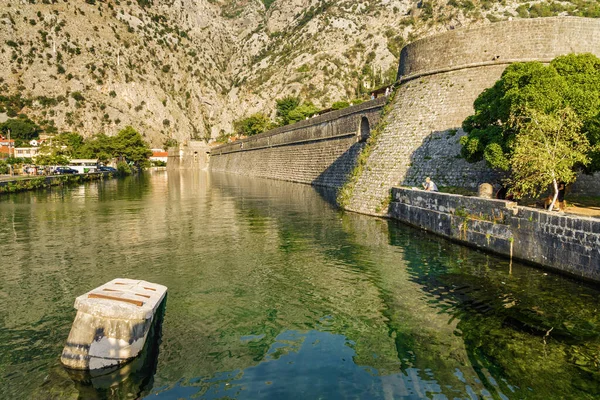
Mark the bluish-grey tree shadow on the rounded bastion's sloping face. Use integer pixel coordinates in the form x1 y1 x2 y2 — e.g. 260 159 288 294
401 128 499 189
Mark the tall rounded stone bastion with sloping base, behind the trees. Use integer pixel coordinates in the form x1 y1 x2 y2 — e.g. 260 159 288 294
348 17 600 215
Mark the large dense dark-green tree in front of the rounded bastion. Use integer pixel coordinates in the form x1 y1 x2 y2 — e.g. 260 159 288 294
460 54 600 194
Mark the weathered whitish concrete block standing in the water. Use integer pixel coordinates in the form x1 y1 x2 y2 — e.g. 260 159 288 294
61 278 167 370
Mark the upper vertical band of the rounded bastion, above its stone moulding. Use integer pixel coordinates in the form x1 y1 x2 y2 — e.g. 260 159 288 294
398 17 600 81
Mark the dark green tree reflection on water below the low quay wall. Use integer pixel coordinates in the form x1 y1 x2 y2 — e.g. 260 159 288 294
390 220 600 398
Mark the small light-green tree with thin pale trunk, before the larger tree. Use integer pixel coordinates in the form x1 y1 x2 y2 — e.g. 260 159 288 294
508 107 590 210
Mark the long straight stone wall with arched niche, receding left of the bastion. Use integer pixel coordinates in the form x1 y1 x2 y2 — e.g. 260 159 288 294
209 97 387 188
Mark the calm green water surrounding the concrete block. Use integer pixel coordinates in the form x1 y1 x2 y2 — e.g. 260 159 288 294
0 172 600 399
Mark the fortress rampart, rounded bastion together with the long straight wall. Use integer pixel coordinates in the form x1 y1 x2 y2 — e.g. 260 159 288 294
210 17 600 209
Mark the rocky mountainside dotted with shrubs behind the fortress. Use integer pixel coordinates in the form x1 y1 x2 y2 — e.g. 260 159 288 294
0 0 600 146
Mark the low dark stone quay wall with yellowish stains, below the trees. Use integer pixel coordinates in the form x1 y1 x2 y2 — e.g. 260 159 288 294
389 188 600 282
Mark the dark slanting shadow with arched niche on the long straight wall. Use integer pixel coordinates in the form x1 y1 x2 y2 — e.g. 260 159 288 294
311 116 371 189
